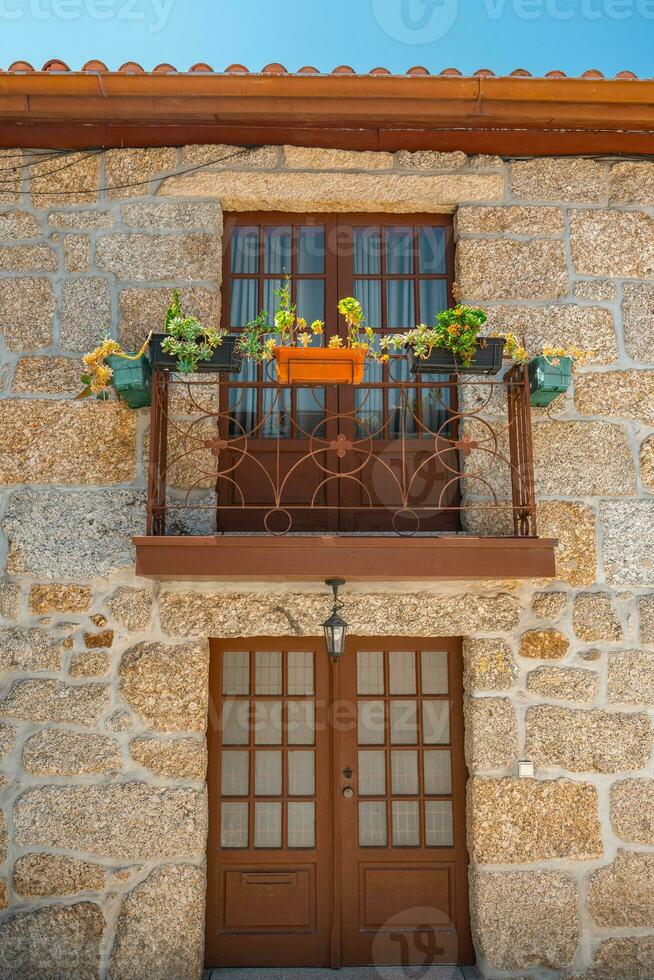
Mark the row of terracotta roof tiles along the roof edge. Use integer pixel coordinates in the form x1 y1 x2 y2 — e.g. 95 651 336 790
0 58 638 80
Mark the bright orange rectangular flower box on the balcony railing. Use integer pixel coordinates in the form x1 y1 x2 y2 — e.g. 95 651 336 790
273 347 366 385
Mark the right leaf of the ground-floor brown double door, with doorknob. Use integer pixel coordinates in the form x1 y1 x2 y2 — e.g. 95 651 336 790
338 638 473 966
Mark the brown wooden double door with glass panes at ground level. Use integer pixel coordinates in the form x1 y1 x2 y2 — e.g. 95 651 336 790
205 637 474 967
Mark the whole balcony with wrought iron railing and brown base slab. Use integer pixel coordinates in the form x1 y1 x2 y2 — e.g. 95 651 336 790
135 367 555 581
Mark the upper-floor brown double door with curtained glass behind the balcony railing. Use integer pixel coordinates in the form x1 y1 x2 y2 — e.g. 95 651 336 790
217 212 459 532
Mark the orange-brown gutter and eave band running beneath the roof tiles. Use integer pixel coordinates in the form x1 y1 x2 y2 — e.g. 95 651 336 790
0 72 654 155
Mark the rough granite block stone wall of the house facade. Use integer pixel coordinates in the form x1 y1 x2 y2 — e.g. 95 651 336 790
0 147 654 980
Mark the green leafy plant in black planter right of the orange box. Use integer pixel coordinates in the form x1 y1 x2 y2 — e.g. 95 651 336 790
382 306 488 367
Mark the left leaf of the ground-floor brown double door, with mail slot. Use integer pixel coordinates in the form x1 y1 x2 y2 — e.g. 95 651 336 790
206 639 332 966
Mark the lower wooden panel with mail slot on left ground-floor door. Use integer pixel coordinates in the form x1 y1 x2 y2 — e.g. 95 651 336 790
223 865 315 932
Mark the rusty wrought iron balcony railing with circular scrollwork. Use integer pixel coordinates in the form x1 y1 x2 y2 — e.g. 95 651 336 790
148 367 536 537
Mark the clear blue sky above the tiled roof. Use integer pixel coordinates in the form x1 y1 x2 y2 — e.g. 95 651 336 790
0 0 654 77
